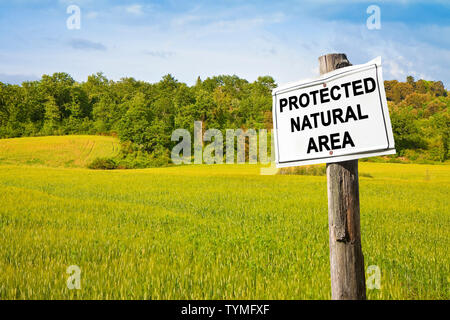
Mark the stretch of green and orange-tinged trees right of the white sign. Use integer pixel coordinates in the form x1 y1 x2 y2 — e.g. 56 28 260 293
384 76 450 162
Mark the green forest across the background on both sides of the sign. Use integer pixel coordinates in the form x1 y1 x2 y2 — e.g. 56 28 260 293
0 73 450 168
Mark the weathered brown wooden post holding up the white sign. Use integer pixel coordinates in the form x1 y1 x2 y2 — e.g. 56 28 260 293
319 53 366 300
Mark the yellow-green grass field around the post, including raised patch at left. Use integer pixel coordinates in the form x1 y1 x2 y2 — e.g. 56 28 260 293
0 136 450 299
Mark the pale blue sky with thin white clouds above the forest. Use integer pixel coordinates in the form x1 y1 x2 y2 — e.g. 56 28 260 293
0 0 450 88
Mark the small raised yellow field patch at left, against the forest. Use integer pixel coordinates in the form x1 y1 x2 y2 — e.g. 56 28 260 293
0 136 120 168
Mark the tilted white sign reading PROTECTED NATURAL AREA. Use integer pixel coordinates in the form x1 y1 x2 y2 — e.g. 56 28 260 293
272 57 395 168
